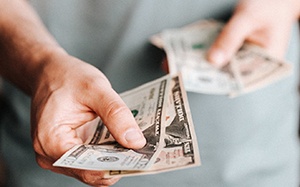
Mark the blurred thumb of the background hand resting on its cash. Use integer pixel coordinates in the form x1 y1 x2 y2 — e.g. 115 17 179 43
207 12 255 67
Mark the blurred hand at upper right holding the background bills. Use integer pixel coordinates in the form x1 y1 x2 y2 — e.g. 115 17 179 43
208 0 300 67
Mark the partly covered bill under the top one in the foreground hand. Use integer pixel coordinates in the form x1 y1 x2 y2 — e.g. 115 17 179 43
108 76 201 176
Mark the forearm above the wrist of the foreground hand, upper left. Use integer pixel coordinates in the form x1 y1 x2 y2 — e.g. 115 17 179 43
0 0 65 94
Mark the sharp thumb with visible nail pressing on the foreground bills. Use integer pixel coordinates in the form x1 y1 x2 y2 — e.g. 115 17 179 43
87 82 146 149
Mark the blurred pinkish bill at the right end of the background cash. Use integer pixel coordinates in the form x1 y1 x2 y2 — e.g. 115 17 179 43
229 44 292 97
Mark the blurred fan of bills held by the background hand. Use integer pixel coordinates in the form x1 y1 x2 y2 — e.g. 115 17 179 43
150 20 292 97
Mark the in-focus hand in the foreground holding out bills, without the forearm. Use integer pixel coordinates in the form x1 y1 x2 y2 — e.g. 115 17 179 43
31 53 146 186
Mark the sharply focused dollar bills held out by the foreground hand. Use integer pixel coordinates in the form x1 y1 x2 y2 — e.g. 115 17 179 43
53 75 200 177
